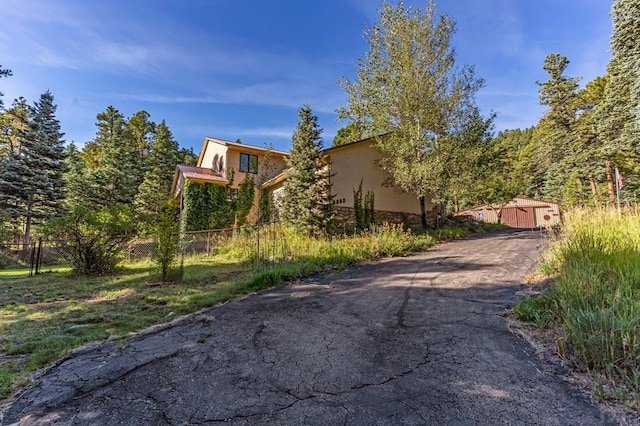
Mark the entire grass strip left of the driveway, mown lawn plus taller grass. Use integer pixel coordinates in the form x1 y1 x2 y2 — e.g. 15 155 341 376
0 221 492 398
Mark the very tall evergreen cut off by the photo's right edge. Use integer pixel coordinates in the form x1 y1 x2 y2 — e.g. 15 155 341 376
597 0 640 198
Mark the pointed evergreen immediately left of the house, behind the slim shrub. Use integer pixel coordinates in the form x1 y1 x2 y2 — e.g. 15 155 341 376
135 120 178 226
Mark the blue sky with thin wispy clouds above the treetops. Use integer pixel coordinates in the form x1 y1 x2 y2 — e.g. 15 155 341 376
0 0 611 152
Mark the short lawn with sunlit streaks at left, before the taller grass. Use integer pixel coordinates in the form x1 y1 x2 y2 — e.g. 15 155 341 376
0 257 252 397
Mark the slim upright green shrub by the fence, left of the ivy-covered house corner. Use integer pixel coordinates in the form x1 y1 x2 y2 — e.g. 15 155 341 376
152 203 180 282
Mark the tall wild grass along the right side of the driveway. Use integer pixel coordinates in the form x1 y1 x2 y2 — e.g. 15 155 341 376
514 210 640 410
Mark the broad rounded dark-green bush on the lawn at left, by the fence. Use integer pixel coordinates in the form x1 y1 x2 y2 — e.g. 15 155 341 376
46 206 134 275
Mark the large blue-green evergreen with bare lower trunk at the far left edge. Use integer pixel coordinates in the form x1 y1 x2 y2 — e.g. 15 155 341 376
0 91 64 245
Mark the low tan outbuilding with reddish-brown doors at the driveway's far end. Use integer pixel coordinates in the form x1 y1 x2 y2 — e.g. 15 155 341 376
456 197 560 228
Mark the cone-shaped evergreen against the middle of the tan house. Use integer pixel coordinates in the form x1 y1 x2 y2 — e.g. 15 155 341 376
282 105 333 235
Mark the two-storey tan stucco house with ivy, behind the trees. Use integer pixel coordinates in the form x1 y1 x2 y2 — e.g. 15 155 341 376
172 137 433 228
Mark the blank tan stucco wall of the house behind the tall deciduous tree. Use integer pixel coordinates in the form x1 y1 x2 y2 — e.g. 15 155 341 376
327 141 433 214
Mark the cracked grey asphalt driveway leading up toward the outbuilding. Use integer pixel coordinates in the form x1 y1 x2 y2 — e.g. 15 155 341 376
2 230 617 425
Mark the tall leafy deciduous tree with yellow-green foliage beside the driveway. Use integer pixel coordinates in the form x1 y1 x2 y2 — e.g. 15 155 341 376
338 0 483 227
